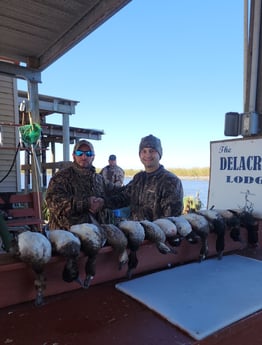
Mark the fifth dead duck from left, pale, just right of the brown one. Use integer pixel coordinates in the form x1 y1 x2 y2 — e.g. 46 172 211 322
118 220 145 278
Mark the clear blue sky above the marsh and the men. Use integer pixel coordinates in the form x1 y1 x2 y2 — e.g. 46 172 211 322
18 0 244 169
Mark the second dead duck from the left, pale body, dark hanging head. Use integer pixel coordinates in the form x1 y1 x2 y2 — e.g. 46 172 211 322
48 229 82 286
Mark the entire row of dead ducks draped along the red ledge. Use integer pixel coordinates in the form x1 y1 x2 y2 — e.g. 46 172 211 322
10 209 258 305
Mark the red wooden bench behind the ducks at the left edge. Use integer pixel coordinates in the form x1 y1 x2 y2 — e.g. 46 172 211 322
0 192 44 234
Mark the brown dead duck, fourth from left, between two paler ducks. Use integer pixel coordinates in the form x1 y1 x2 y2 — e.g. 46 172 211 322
101 224 128 269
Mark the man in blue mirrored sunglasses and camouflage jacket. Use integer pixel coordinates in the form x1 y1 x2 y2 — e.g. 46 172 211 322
45 140 117 230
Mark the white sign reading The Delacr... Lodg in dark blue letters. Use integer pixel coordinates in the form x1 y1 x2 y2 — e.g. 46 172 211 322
207 137 262 218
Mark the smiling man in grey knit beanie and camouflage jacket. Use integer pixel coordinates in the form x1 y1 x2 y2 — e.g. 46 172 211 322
104 135 183 221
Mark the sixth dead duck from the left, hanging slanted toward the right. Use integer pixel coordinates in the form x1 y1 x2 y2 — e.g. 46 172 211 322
140 220 176 254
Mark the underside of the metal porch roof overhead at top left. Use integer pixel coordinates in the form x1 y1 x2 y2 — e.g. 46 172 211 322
0 0 131 71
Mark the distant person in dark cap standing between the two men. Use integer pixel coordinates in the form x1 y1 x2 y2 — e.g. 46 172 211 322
100 155 125 187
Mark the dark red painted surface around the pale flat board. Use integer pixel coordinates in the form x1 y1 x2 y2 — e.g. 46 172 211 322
0 249 262 345
